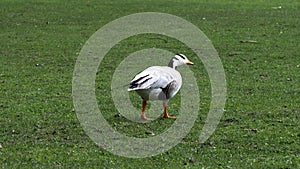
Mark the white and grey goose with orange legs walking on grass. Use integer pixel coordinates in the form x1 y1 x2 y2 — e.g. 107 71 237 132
128 54 193 120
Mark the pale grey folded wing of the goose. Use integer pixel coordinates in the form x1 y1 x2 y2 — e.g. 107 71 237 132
128 66 175 91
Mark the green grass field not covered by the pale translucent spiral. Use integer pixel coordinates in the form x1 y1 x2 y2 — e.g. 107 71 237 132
0 0 300 168
